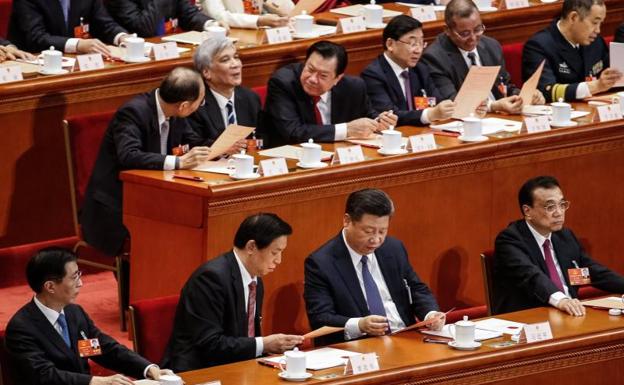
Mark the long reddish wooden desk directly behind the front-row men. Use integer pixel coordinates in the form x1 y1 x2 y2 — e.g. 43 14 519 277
121 107 624 332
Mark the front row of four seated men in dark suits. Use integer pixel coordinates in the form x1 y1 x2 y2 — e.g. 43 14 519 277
6 176 624 385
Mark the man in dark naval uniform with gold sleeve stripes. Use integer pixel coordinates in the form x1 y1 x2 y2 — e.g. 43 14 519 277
522 0 622 102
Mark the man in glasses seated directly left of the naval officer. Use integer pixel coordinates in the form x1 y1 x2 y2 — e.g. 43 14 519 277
422 0 544 114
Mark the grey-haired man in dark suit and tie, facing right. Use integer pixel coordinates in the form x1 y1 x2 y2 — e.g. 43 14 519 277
189 37 261 154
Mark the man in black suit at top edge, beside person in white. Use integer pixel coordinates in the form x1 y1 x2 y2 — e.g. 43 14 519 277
106 0 218 37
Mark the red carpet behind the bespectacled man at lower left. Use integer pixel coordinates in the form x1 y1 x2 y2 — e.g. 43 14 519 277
0 271 132 349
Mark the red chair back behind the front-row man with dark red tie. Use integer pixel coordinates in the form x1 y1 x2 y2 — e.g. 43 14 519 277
130 295 180 363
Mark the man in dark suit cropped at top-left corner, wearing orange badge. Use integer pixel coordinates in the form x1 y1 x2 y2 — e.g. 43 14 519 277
9 0 126 56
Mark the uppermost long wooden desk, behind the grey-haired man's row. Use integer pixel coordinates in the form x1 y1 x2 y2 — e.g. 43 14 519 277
0 0 624 247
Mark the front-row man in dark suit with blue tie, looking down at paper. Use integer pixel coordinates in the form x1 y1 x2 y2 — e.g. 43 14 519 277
303 189 445 343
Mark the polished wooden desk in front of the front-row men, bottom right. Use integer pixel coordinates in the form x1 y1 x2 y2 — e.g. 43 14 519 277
181 308 624 385
